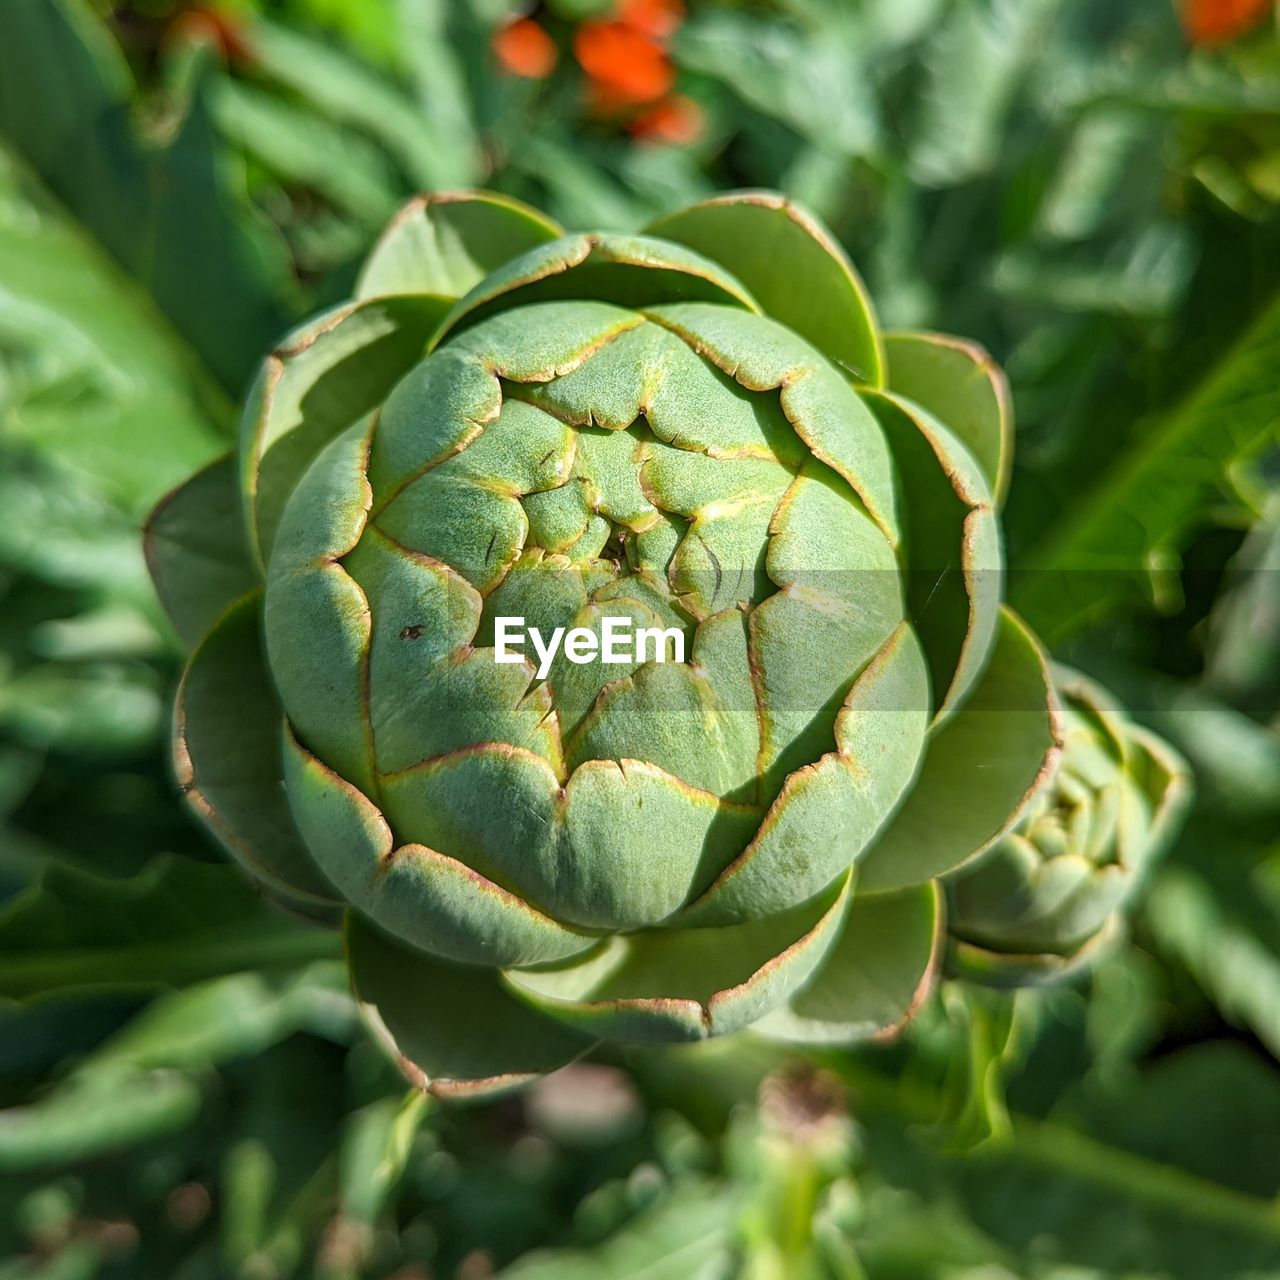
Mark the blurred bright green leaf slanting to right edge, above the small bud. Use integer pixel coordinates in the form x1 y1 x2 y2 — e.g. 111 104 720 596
1012 288 1280 643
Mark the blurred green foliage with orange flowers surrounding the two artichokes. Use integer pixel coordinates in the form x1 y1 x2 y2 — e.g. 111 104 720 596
0 0 1280 1280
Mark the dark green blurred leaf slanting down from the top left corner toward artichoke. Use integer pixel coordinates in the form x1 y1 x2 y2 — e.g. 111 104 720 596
0 0 287 393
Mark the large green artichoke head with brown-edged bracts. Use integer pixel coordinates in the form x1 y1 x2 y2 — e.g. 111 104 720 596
148 193 1060 1093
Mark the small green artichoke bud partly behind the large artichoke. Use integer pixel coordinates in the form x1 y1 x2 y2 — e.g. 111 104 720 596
946 667 1190 987
